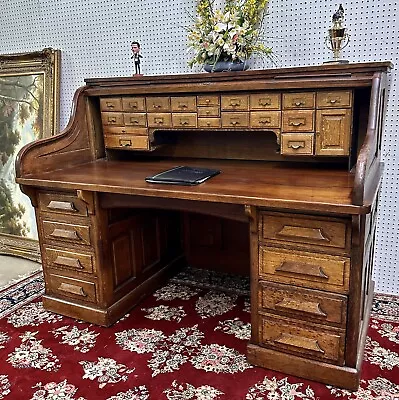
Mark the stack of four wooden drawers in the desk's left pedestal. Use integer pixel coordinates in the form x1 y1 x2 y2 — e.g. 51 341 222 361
38 191 99 303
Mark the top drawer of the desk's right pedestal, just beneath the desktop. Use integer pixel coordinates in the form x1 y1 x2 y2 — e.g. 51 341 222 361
259 213 351 252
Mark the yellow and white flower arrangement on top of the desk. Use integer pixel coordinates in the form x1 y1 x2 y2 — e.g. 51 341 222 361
187 0 272 67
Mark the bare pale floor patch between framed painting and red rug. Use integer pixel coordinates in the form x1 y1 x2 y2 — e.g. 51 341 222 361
0 255 41 289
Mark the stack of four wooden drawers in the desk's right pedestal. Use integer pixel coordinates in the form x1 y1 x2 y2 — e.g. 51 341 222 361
258 212 351 365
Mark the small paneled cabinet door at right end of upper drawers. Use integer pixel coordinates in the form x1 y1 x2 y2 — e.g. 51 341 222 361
315 109 352 156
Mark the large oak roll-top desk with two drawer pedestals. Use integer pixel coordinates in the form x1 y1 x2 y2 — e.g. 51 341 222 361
17 62 392 389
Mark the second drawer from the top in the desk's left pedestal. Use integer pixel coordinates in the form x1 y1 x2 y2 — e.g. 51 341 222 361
43 220 91 246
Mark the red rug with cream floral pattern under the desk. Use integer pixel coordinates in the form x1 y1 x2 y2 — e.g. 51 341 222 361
0 271 399 400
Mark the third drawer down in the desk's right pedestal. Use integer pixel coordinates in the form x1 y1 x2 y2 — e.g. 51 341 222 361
259 281 347 328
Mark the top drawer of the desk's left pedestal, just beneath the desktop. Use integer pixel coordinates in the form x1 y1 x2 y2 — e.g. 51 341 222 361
39 193 88 216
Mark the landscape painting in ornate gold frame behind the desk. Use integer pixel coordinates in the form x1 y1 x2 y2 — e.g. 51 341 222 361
0 48 61 261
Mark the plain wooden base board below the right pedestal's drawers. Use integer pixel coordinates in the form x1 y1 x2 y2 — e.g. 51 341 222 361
247 343 360 390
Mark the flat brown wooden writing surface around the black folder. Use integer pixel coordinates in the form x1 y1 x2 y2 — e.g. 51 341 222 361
19 159 367 214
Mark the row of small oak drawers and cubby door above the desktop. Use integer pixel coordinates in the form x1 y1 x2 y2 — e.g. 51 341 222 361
100 90 352 156
